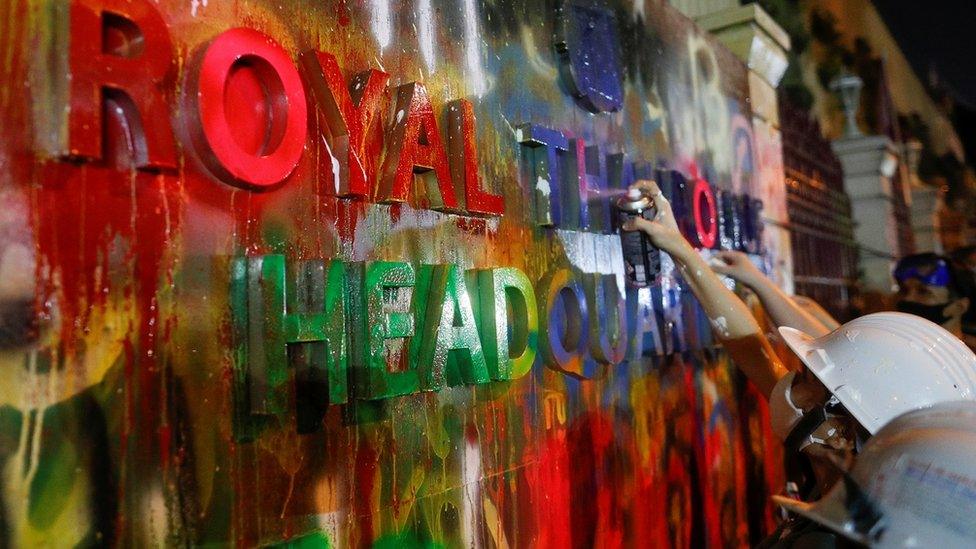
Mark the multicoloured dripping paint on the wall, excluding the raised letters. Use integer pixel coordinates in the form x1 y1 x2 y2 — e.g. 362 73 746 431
0 0 779 547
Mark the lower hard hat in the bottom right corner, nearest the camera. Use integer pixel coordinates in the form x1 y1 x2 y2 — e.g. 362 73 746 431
773 401 976 549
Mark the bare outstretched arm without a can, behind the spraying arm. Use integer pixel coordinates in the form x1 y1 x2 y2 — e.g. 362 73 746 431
710 252 830 337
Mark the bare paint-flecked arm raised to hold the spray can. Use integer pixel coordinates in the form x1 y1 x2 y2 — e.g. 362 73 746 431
624 181 786 396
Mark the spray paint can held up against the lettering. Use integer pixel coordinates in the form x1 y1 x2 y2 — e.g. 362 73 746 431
616 189 661 288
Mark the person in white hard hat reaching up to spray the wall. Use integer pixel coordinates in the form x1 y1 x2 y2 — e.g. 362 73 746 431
624 181 976 510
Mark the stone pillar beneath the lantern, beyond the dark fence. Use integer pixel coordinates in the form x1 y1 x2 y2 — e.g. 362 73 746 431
833 135 899 293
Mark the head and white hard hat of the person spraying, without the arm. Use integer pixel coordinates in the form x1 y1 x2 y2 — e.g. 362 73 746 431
770 312 976 494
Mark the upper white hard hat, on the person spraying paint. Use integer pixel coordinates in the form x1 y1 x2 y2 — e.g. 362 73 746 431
779 313 976 435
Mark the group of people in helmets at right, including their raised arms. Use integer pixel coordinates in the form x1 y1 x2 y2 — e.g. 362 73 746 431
623 181 976 548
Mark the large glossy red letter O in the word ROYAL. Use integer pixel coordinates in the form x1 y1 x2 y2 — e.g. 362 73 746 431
188 29 308 189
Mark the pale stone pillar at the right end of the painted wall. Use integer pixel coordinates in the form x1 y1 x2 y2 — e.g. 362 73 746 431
695 2 793 293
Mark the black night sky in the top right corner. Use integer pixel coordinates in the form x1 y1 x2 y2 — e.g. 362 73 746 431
874 0 976 164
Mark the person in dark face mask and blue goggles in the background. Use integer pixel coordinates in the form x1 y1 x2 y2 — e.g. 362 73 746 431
893 253 969 338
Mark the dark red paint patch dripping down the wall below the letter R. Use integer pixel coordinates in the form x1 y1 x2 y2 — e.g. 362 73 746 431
30 97 181 535
